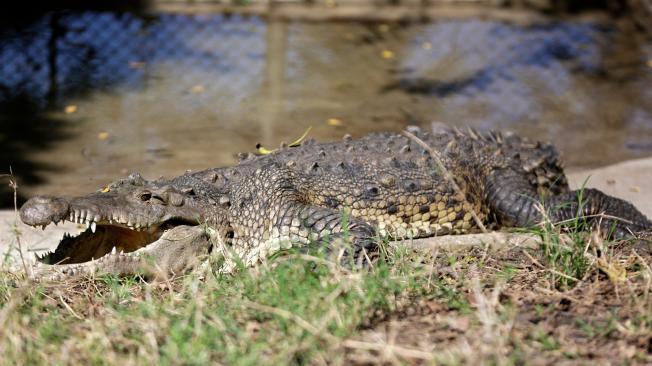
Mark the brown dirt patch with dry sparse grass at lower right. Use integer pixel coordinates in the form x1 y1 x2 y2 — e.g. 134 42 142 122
347 243 652 365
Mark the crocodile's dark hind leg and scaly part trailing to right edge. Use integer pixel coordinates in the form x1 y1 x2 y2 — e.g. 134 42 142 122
486 170 652 238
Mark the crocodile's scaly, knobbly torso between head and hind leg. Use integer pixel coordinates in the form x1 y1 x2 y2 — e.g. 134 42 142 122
176 127 566 266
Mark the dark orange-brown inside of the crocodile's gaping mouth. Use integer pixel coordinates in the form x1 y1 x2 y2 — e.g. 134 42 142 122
38 215 198 264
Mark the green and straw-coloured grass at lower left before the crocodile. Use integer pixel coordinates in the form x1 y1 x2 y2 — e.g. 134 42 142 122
0 240 426 364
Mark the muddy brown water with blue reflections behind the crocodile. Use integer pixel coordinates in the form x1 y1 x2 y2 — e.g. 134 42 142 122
0 12 652 202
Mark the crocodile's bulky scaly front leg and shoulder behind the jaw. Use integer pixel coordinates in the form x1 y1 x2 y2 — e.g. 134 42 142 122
224 163 376 266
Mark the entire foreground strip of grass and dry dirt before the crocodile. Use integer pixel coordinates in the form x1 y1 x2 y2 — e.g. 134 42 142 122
0 229 652 364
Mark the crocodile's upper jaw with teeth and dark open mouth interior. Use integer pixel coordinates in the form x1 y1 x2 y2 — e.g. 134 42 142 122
20 190 209 264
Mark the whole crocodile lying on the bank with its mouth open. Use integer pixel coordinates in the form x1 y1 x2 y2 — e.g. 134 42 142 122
20 126 652 274
